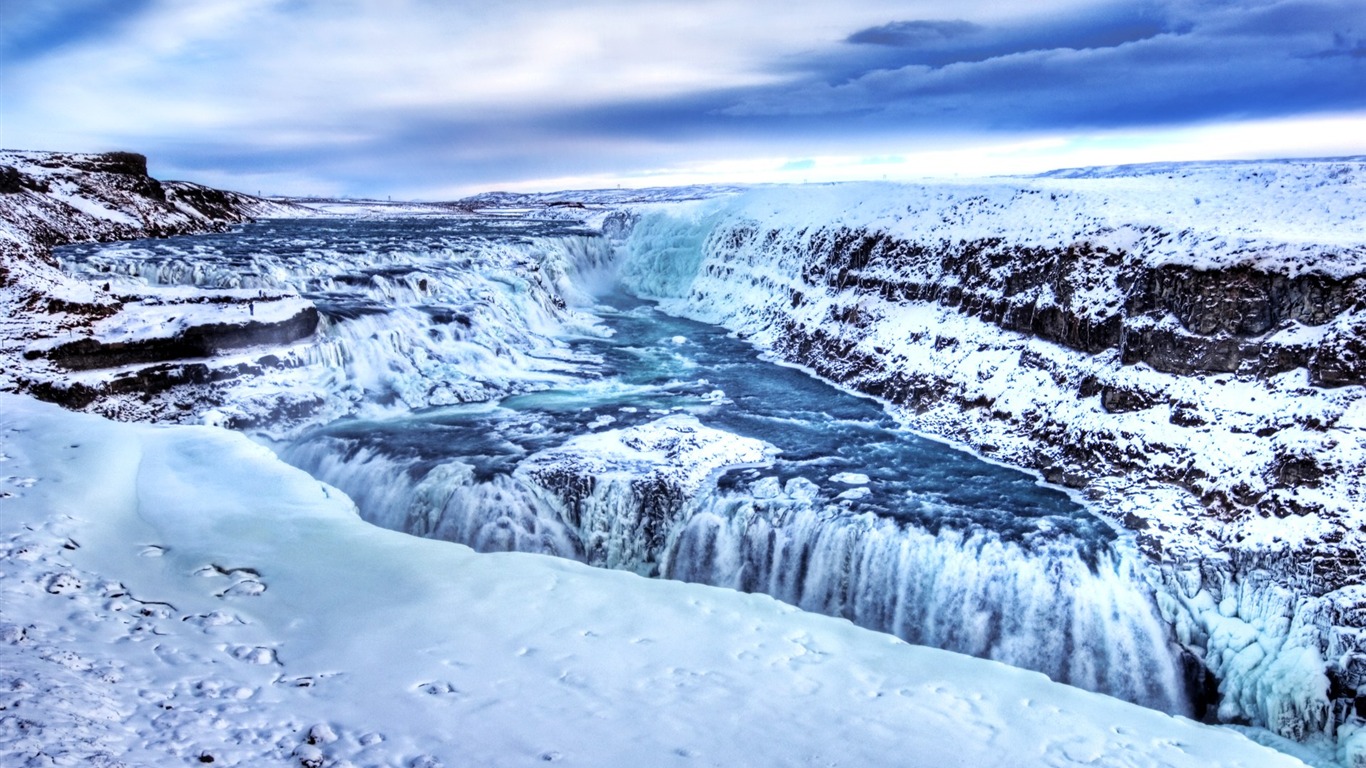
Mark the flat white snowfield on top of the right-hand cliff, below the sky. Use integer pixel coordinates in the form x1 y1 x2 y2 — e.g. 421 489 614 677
620 159 1366 277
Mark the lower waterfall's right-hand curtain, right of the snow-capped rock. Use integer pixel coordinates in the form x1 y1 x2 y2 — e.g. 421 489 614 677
664 478 1188 712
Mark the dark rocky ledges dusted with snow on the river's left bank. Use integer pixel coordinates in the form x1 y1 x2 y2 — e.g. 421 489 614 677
0 150 318 418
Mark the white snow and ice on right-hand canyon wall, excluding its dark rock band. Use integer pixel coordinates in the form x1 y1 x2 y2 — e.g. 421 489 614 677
622 159 1366 748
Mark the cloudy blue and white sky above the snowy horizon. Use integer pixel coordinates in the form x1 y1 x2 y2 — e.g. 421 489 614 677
0 0 1366 200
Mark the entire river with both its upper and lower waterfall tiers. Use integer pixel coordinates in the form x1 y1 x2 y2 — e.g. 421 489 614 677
67 212 1188 713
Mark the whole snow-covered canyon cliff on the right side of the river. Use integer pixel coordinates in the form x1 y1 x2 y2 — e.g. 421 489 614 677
623 160 1366 738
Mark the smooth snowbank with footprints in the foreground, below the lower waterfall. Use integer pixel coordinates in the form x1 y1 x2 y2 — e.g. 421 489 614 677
0 395 1302 768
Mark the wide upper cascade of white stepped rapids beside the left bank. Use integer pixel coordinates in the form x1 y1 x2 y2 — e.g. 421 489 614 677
61 217 615 415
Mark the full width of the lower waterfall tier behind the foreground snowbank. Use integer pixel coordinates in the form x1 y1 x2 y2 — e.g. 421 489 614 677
281 437 1190 715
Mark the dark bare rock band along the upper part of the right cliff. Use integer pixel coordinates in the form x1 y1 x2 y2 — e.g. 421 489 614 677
743 225 1366 387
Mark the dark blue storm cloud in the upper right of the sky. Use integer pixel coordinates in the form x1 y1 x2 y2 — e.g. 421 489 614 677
725 0 1366 130
